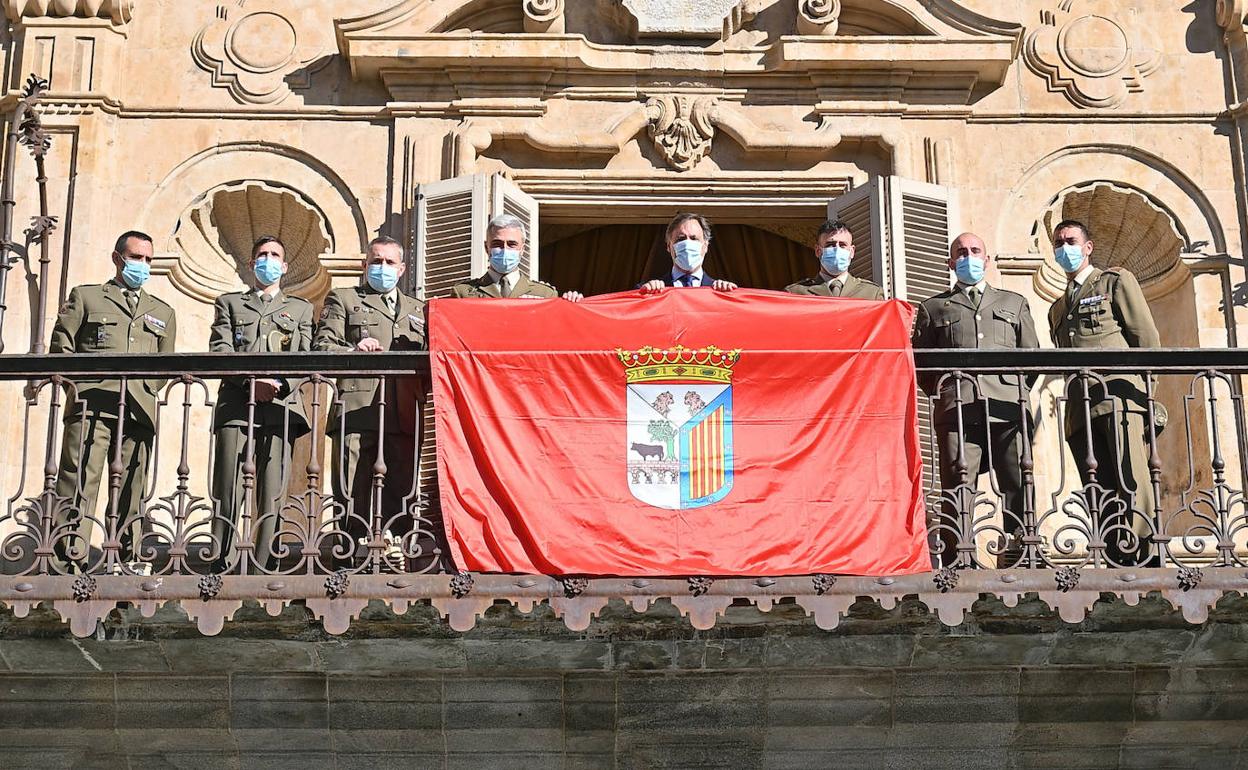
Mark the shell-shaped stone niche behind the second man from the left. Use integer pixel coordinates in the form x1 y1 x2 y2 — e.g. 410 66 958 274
170 182 333 302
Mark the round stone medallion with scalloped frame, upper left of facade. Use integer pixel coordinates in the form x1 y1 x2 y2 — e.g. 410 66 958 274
191 0 329 105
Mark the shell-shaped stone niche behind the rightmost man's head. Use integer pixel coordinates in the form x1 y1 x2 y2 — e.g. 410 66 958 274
1042 182 1183 283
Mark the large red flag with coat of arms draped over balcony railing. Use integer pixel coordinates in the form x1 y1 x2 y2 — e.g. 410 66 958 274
429 288 930 575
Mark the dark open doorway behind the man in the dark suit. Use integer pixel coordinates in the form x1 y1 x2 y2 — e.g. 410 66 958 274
538 221 819 296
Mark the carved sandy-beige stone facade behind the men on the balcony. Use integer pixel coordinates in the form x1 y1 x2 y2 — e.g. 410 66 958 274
0 0 1248 559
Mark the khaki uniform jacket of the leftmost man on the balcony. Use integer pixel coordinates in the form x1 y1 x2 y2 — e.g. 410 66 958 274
49 281 177 426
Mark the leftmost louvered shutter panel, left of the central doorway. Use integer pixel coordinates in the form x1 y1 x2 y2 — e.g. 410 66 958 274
409 175 489 300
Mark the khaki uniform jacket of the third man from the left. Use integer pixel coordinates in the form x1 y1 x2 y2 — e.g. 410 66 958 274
312 286 424 434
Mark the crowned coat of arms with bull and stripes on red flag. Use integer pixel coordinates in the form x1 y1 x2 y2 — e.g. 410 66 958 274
615 344 741 510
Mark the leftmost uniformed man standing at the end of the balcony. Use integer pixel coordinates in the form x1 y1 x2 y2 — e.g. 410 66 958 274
49 231 177 573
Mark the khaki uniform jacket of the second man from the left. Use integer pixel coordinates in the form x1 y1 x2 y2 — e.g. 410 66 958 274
208 291 312 433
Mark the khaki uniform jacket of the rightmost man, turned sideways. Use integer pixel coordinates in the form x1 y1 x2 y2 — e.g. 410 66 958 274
1048 268 1162 433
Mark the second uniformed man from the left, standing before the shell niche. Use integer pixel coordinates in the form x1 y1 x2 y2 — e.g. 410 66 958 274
208 236 312 570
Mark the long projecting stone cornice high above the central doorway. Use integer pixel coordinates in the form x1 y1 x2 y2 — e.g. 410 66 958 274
339 31 1016 105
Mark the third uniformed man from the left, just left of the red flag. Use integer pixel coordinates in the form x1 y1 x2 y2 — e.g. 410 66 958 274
312 236 424 562
